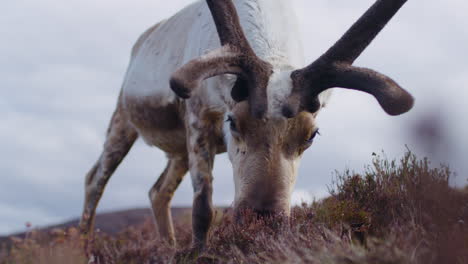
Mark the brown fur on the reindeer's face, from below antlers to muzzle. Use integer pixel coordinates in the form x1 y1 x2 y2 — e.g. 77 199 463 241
232 103 316 214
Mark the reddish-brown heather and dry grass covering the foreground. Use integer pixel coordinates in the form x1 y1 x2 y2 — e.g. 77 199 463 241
0 153 468 264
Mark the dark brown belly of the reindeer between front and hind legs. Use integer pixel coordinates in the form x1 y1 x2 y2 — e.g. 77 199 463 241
123 95 187 155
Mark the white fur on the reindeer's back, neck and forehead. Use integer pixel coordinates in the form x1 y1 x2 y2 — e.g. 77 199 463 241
123 0 310 114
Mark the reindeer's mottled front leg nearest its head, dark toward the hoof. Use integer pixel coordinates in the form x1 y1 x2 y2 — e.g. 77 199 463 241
186 104 222 250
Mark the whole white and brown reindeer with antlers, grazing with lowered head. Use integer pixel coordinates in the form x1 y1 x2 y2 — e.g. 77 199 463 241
80 0 413 248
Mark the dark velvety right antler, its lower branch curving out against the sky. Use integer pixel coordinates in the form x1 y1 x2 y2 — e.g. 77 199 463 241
283 0 414 117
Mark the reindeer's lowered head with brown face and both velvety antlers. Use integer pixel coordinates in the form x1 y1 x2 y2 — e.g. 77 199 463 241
171 0 413 218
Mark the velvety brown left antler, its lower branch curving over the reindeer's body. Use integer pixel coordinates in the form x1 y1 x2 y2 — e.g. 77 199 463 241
170 0 273 118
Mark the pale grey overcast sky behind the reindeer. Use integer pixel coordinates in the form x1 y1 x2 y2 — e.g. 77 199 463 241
0 0 468 234
